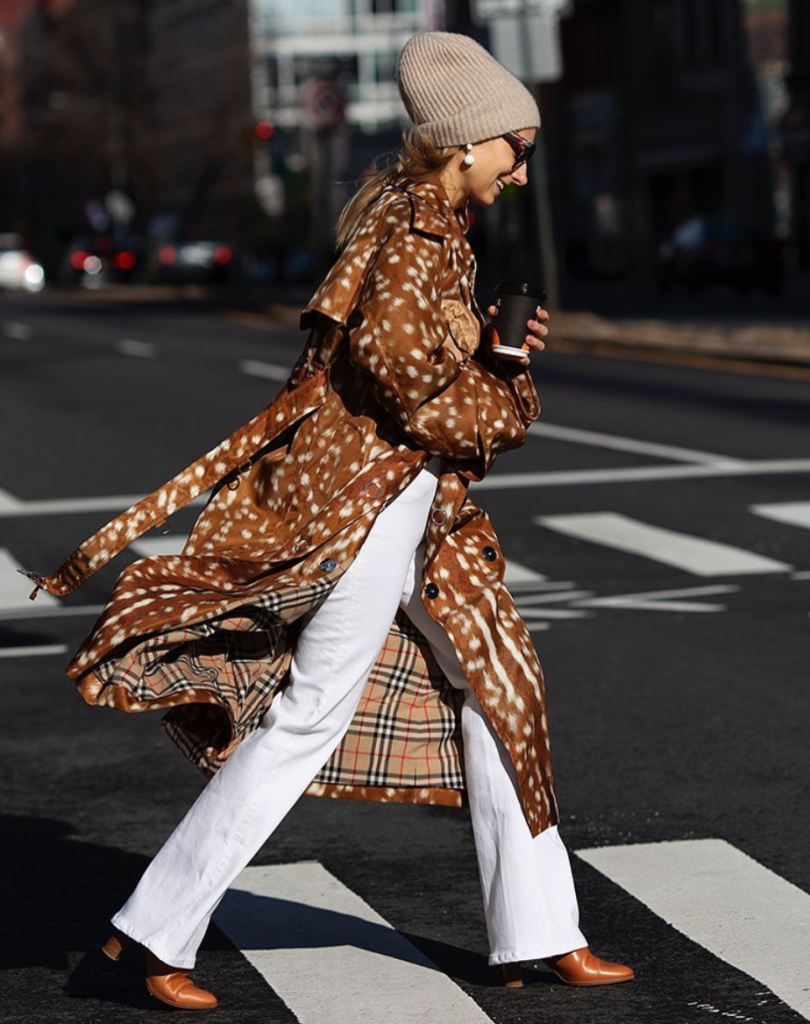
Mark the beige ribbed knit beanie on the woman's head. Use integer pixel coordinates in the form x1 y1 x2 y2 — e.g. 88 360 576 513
396 32 540 145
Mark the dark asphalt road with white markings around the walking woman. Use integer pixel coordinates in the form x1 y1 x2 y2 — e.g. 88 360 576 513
0 296 810 1024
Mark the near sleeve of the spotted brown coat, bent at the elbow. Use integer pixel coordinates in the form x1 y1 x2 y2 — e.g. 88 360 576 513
349 216 535 476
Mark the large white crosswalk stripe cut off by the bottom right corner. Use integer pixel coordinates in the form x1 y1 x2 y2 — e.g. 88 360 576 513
577 839 810 1018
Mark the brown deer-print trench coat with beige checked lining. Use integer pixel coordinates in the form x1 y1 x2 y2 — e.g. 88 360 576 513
32 182 557 835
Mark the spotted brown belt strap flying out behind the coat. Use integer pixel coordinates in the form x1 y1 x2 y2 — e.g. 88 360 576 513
17 367 329 601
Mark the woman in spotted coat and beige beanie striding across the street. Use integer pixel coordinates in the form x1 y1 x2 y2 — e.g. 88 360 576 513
26 33 633 1010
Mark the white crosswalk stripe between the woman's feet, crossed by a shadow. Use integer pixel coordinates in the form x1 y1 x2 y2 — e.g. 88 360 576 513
214 861 492 1024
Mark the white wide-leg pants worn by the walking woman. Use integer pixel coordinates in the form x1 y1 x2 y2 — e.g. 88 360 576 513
113 458 587 968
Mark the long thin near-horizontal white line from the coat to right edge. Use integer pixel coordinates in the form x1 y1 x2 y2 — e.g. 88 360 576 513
471 459 810 490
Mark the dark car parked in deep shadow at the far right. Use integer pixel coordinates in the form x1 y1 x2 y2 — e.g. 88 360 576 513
657 216 784 295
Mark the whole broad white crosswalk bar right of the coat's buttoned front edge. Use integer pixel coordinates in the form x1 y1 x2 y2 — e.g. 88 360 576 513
534 512 793 577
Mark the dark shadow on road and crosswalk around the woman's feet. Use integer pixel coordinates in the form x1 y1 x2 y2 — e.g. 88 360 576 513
0 815 524 1008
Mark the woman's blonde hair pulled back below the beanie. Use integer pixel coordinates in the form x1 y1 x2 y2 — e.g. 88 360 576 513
335 127 466 249
